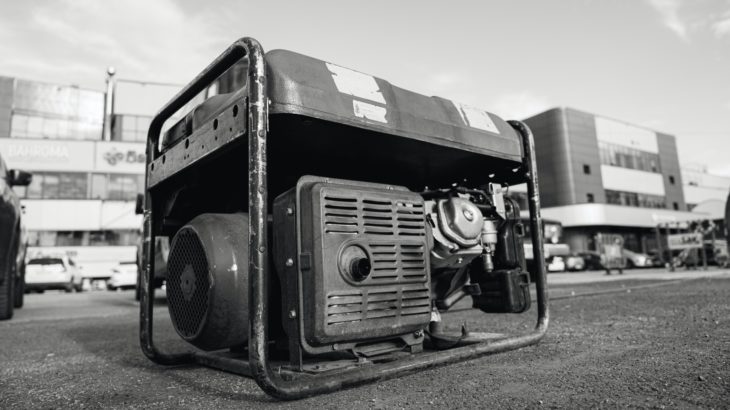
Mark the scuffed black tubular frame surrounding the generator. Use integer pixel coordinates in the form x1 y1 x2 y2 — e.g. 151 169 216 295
140 37 549 400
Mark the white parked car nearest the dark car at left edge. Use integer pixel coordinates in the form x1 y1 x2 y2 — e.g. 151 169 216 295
25 255 83 293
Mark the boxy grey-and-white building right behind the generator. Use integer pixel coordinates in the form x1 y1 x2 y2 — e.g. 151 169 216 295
524 108 698 253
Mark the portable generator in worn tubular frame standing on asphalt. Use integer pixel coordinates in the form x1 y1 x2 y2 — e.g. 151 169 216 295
140 38 548 399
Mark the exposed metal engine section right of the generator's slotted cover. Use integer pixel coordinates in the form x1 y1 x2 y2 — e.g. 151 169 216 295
422 183 529 312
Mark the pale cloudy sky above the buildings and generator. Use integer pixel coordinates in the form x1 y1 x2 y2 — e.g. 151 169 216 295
0 0 730 176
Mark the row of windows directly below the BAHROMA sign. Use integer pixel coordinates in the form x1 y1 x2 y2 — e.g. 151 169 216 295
13 172 144 201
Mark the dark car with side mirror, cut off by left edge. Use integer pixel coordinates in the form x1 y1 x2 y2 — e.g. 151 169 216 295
0 156 33 320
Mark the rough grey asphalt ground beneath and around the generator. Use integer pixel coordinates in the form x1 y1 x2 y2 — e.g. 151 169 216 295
0 268 730 409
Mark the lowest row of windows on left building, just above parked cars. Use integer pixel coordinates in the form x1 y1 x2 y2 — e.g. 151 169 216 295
28 230 141 246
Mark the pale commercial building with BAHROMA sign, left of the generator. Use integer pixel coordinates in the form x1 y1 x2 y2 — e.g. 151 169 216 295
0 77 149 269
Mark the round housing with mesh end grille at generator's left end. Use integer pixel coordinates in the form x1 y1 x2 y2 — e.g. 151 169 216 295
166 213 249 350
